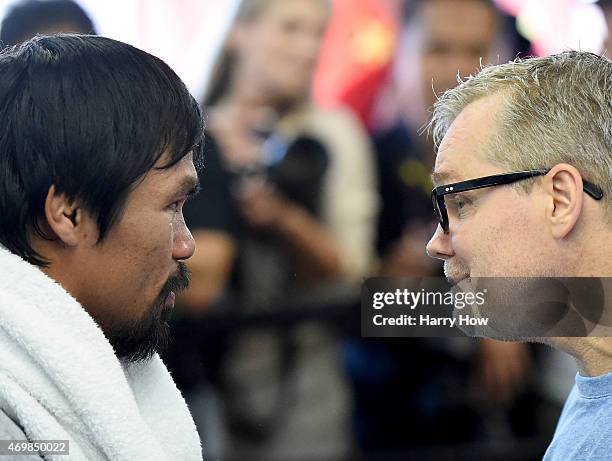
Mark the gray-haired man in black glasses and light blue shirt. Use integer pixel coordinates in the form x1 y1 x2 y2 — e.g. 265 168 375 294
427 51 612 460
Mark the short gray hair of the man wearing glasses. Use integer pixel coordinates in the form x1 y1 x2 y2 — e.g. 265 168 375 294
430 51 612 216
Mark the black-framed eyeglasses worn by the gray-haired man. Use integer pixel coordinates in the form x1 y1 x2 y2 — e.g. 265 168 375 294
431 170 603 233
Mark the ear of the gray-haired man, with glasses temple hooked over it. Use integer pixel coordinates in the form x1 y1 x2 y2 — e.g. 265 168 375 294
547 163 584 239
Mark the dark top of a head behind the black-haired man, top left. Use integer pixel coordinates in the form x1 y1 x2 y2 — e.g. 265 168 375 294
0 0 96 46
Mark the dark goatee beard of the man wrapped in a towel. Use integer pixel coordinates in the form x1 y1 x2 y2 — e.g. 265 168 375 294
106 262 190 362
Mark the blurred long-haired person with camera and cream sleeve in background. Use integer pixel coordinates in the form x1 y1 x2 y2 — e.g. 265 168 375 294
164 0 377 461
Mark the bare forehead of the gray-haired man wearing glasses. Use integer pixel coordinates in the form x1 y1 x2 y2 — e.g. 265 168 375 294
433 95 502 186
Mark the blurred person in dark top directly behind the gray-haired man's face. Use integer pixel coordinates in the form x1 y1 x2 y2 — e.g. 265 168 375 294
346 0 544 453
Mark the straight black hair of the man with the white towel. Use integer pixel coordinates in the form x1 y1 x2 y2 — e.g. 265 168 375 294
0 34 203 267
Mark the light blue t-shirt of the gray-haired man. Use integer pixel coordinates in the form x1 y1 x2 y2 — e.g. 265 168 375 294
543 373 612 461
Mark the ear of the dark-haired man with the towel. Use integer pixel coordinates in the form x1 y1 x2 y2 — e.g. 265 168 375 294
45 185 83 246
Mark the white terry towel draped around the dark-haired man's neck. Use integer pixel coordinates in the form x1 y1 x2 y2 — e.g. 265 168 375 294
0 246 202 461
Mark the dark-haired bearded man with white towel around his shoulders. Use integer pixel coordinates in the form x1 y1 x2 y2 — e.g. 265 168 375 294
0 35 202 461
